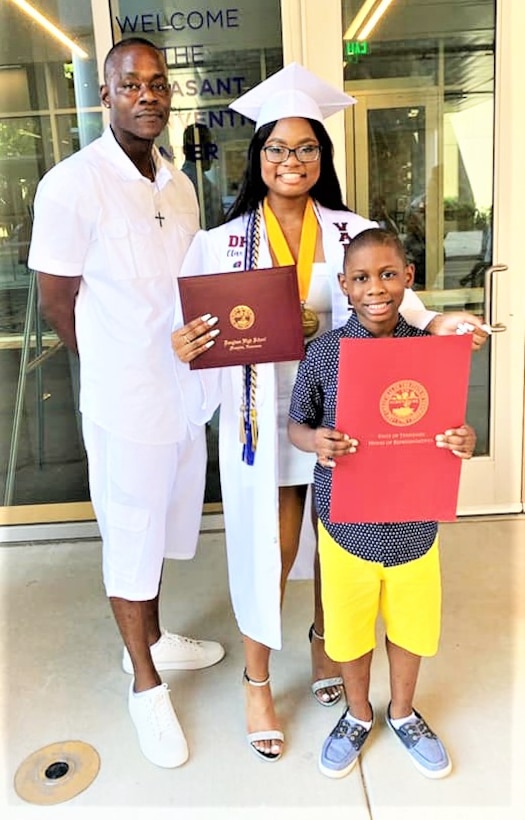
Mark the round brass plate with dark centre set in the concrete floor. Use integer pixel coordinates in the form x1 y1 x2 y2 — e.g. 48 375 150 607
14 740 100 806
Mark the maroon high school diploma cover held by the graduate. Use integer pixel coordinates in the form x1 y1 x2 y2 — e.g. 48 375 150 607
178 265 304 370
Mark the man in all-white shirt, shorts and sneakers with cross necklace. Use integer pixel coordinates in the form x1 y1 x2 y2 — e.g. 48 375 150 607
29 38 224 767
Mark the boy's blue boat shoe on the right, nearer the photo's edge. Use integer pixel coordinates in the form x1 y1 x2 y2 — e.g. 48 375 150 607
385 704 452 780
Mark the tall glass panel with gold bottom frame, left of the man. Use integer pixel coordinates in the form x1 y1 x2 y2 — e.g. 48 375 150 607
0 0 98 527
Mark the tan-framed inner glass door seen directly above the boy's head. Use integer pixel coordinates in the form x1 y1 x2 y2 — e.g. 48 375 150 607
350 89 443 290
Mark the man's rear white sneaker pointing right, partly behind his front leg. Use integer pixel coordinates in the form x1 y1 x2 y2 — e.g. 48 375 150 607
122 630 224 675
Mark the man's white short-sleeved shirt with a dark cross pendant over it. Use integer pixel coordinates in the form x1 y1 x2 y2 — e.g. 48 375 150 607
28 128 200 444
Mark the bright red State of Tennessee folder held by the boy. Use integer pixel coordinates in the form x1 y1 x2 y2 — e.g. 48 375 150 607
330 335 472 523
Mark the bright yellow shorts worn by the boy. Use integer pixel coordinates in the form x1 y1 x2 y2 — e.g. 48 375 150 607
319 521 441 662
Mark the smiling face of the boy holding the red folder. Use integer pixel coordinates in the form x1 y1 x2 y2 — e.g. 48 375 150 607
339 243 414 336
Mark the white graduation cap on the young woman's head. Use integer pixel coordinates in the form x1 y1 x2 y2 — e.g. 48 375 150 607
229 63 356 130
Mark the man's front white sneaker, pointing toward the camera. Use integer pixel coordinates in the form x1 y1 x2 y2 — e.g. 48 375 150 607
128 682 189 769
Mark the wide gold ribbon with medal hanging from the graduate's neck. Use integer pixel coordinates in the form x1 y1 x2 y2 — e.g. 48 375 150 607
263 198 319 338
